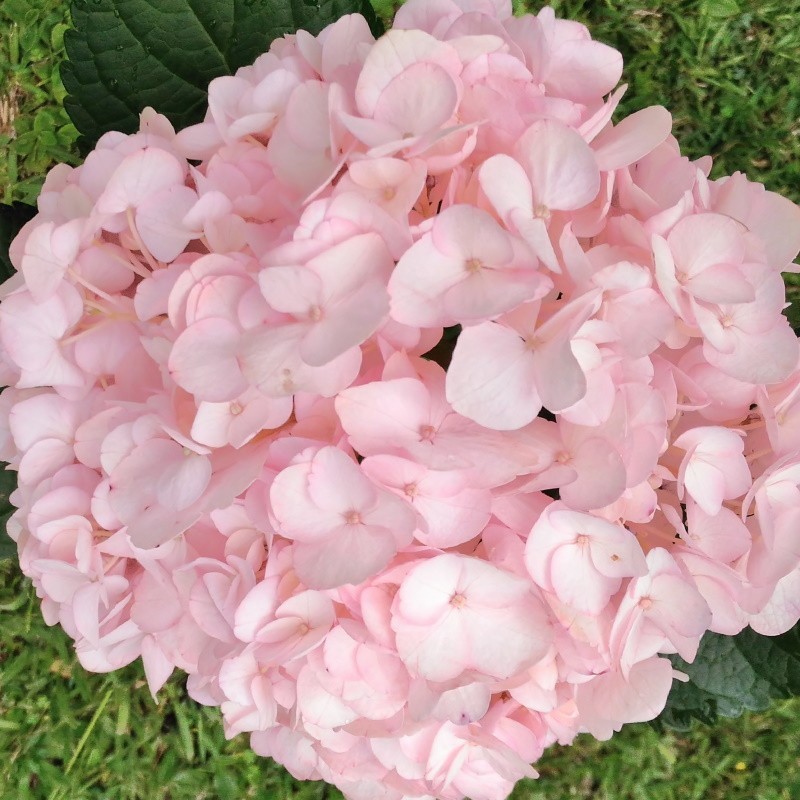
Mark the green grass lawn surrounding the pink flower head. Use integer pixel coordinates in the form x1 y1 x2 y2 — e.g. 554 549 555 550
0 0 800 800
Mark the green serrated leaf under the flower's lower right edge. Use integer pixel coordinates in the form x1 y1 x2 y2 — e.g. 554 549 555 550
656 625 800 730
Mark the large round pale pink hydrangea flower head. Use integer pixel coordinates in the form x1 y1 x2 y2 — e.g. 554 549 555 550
0 0 800 800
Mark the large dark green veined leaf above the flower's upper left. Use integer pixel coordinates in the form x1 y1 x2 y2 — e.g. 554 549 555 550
61 0 380 150
